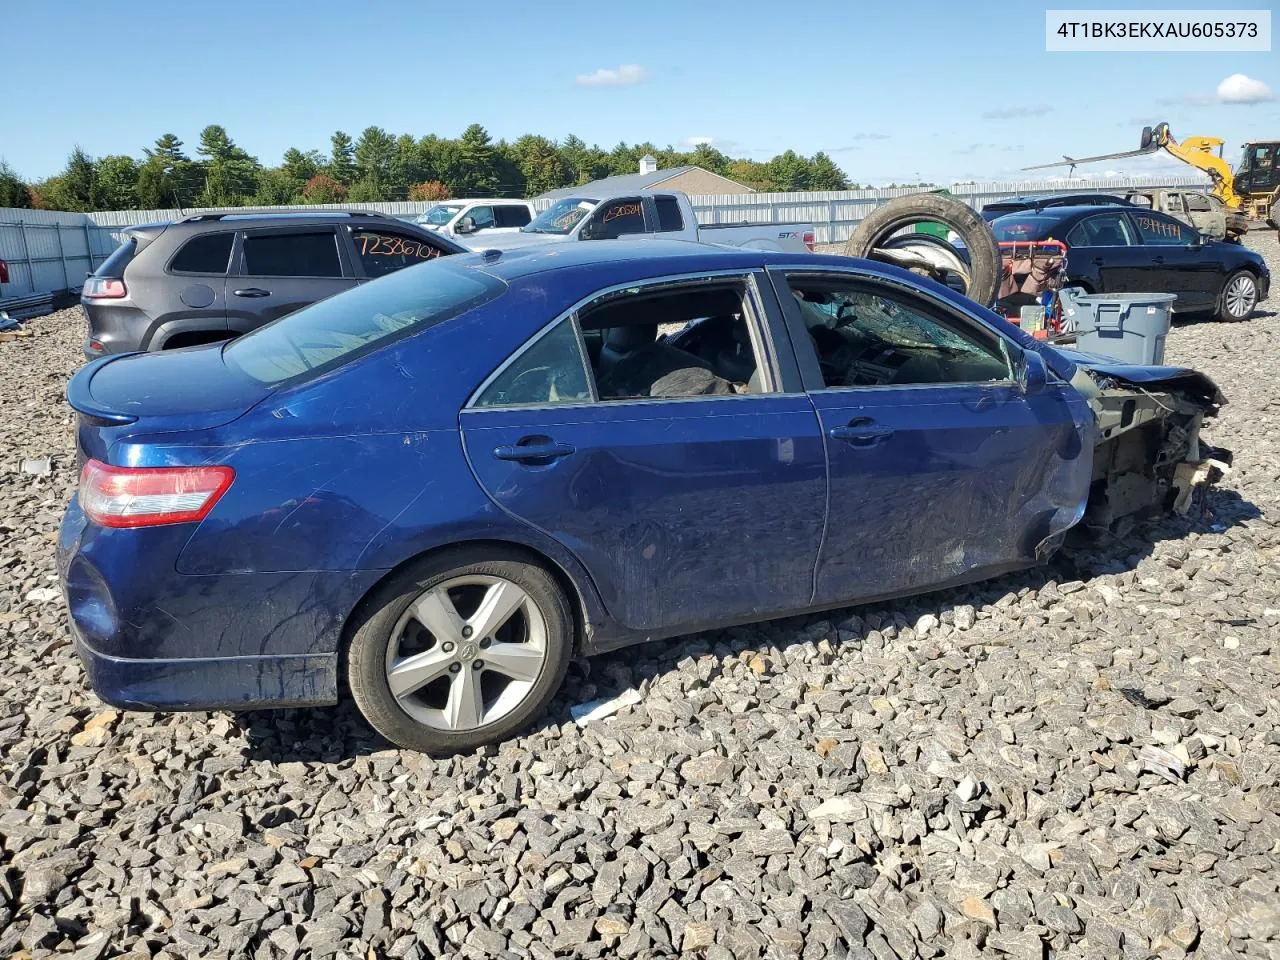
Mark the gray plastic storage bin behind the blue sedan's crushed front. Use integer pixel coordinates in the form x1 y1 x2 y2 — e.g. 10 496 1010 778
1057 287 1176 365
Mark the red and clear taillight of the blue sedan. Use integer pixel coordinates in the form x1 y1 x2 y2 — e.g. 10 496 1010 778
79 460 236 527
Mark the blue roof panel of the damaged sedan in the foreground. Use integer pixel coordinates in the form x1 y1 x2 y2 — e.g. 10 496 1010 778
471 239 849 280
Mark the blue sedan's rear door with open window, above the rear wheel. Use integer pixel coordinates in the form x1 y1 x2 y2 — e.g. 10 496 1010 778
461 275 827 636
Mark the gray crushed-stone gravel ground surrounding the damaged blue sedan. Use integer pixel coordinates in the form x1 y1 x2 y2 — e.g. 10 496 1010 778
0 236 1280 960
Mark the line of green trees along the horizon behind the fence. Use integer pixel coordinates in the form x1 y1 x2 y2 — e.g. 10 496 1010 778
0 123 856 211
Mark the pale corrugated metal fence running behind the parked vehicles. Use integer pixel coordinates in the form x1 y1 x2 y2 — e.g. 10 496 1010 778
0 177 1207 305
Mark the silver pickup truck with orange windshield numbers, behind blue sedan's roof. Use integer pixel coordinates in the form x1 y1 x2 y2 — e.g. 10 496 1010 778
460 189 813 252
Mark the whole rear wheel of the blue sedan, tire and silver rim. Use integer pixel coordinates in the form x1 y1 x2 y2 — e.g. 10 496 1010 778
347 548 573 754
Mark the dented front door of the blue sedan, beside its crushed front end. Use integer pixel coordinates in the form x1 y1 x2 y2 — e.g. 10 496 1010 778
776 270 1093 604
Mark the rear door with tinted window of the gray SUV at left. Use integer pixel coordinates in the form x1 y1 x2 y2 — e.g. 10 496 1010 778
227 225 357 333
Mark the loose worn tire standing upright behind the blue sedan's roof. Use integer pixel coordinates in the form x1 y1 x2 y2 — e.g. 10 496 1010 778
845 193 1001 307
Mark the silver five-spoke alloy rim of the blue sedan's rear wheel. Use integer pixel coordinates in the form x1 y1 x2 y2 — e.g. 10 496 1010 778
387 575 548 732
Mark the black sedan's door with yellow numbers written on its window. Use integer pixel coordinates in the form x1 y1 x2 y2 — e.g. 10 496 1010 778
1129 210 1225 310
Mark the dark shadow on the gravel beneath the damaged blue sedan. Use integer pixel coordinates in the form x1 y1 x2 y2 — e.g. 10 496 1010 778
234 488 1262 763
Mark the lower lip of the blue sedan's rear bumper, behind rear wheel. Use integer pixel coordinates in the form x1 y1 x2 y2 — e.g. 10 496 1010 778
72 625 338 710
